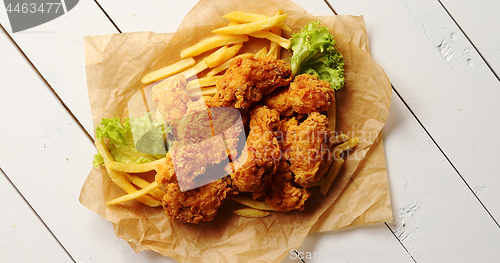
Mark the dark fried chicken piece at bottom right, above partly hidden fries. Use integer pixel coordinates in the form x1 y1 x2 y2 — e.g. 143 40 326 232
265 160 311 212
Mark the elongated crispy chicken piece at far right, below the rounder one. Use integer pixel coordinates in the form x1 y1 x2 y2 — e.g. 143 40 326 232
282 112 330 188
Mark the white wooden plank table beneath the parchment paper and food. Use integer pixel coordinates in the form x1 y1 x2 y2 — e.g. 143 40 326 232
0 0 500 263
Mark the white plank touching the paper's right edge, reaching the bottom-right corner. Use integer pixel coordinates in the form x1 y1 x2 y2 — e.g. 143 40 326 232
382 93 500 263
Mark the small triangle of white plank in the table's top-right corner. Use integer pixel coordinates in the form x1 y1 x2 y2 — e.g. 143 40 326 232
441 0 500 75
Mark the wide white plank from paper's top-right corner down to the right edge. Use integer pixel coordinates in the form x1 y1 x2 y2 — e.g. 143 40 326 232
329 0 500 225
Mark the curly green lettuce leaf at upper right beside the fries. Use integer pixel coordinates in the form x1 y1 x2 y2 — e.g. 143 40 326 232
290 21 345 90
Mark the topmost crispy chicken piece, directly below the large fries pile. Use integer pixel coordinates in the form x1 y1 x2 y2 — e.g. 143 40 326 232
209 56 292 109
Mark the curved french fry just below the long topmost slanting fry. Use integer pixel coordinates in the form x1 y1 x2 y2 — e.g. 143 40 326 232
181 34 249 58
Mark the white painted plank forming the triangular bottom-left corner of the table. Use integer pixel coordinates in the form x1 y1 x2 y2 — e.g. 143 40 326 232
0 171 72 263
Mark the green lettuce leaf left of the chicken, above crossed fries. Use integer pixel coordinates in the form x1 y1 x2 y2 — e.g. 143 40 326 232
92 112 170 167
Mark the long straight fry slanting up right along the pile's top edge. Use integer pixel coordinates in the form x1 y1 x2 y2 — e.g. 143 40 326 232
212 14 287 35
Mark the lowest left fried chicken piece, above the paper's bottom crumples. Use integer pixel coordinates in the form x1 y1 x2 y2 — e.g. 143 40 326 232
162 176 238 224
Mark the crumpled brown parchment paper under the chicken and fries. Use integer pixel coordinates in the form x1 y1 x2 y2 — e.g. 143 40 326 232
80 0 392 262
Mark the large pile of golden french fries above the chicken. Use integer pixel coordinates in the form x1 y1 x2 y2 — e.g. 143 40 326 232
141 11 291 98
